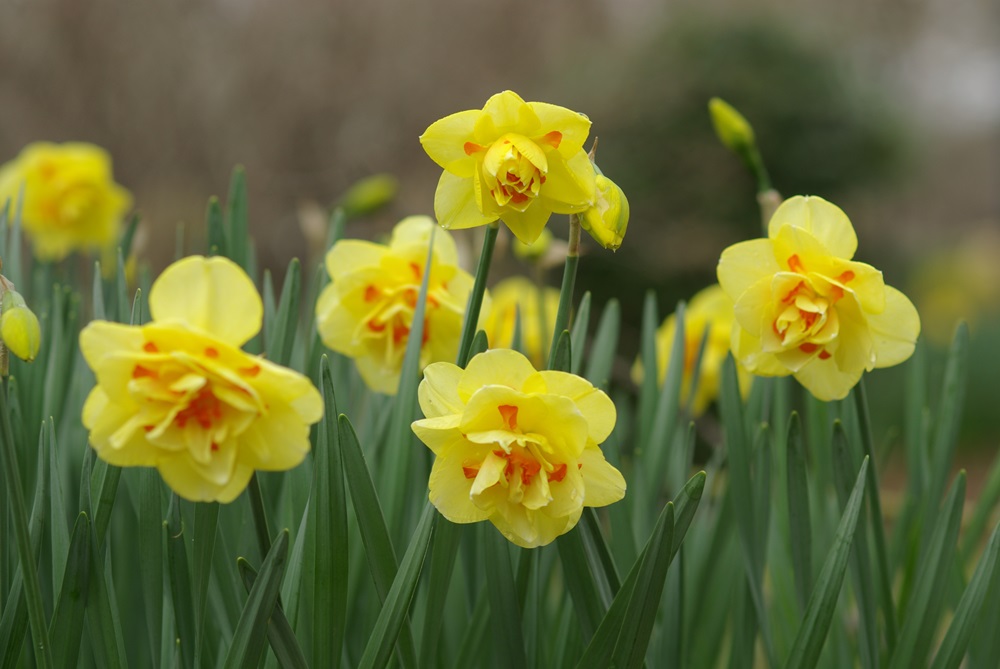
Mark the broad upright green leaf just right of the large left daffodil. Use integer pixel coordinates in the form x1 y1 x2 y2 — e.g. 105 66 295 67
306 356 348 667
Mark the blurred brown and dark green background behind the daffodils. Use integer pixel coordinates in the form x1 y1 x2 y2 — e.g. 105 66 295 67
0 0 1000 448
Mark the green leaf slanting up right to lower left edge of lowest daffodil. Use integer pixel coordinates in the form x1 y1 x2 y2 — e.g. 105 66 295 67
358 502 438 669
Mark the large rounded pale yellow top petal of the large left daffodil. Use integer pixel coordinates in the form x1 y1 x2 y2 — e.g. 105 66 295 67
149 256 264 346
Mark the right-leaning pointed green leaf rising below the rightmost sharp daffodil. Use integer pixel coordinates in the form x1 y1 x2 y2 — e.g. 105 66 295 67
785 457 868 669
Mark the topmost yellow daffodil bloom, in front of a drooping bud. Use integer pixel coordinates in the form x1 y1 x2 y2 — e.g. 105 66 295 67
420 91 596 244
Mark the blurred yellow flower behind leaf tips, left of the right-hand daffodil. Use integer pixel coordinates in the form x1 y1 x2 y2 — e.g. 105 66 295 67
632 284 751 416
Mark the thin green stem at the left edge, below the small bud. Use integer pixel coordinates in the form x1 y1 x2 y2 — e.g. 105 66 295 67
0 378 52 668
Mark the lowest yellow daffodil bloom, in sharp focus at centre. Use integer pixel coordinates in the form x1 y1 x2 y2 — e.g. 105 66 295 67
413 349 625 548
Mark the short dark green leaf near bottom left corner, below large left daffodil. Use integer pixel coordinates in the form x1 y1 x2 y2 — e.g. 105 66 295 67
49 511 90 667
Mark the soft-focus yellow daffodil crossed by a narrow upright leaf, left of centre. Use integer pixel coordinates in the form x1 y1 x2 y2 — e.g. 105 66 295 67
316 216 480 395
